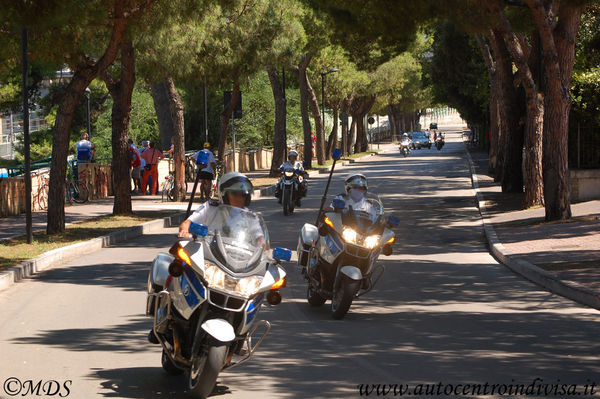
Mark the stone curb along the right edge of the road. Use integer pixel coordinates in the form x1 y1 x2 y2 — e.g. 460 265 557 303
463 142 600 309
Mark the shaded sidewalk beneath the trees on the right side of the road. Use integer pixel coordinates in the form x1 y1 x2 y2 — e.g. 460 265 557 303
467 144 600 309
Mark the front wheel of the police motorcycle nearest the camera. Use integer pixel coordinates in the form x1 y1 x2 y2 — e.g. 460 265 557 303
188 345 227 399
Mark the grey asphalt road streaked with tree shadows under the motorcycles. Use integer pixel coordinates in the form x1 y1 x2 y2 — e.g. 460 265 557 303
0 133 600 399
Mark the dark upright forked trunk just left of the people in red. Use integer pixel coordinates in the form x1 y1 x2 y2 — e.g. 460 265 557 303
101 40 135 215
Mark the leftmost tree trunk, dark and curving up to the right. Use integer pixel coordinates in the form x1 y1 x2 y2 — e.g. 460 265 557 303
46 1 127 234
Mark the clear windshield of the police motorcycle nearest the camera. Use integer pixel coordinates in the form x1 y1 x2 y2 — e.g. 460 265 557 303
205 205 269 274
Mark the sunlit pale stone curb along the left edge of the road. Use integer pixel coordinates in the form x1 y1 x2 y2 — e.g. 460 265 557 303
0 212 185 291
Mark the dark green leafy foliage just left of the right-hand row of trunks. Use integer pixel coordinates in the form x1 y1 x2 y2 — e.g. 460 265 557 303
423 23 489 125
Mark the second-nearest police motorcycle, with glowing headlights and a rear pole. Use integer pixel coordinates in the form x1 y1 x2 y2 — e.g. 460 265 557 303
297 153 398 319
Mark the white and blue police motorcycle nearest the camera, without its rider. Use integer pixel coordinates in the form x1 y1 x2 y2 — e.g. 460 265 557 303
146 205 291 398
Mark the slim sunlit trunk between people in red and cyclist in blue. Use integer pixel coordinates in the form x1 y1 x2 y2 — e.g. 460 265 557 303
164 77 187 201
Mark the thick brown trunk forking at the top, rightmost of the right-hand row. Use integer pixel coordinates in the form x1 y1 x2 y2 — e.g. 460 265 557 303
525 0 585 221
